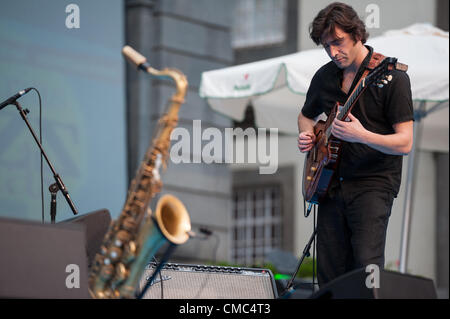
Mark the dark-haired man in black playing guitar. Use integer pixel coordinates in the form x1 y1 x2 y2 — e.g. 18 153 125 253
298 3 413 285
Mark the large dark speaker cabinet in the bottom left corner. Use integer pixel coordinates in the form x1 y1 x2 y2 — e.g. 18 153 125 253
0 218 89 299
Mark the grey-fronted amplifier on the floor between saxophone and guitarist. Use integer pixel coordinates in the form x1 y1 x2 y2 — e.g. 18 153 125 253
139 263 278 299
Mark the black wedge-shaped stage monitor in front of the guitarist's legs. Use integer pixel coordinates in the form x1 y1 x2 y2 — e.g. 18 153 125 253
311 268 437 299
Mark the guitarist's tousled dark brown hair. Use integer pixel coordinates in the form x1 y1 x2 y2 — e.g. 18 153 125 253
309 2 369 45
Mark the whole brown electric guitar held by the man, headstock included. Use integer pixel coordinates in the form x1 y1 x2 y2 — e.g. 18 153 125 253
302 53 408 208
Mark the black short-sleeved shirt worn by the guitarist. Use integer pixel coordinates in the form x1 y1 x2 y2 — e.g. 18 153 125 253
302 46 414 196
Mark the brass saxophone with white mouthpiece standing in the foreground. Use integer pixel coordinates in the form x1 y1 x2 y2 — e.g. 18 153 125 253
89 46 191 298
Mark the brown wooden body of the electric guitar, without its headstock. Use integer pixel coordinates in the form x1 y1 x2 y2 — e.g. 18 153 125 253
303 103 341 204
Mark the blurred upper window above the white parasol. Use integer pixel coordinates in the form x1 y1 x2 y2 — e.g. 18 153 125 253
232 0 287 49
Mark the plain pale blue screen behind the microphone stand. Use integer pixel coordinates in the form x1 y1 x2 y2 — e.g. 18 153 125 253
0 0 128 222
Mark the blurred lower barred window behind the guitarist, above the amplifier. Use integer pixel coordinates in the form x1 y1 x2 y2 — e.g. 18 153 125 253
231 186 282 266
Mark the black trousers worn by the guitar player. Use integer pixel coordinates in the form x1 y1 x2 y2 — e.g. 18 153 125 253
317 182 394 286
